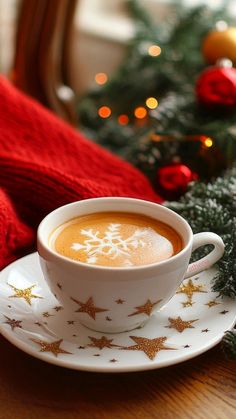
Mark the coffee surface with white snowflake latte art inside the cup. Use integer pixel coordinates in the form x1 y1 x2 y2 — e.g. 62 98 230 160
50 212 183 267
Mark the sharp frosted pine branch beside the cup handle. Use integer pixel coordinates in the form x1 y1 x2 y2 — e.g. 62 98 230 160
167 169 236 298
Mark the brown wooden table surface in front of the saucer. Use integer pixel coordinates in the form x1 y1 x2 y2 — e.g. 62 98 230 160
0 337 236 419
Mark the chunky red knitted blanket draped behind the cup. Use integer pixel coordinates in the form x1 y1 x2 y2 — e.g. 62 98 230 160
0 77 161 268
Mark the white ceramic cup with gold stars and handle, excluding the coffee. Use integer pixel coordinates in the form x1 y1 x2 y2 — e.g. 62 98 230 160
37 198 224 333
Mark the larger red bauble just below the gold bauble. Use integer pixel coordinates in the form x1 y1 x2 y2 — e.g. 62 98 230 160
196 67 236 107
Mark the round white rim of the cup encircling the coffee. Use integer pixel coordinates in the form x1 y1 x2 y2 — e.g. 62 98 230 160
37 197 193 272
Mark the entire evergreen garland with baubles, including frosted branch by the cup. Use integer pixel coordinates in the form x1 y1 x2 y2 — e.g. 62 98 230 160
78 1 236 358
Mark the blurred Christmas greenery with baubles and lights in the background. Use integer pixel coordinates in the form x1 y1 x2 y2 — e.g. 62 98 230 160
78 0 236 199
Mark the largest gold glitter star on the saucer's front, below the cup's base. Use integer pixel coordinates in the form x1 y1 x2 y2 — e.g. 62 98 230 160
120 336 176 360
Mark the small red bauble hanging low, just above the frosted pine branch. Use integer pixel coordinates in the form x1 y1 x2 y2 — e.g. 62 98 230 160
157 163 198 199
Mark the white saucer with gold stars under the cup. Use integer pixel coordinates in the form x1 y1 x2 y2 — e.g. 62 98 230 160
0 253 236 372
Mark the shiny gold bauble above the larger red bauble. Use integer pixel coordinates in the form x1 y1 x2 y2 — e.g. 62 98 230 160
202 27 236 64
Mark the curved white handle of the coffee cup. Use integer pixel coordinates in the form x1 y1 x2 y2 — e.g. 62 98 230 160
184 232 225 279
